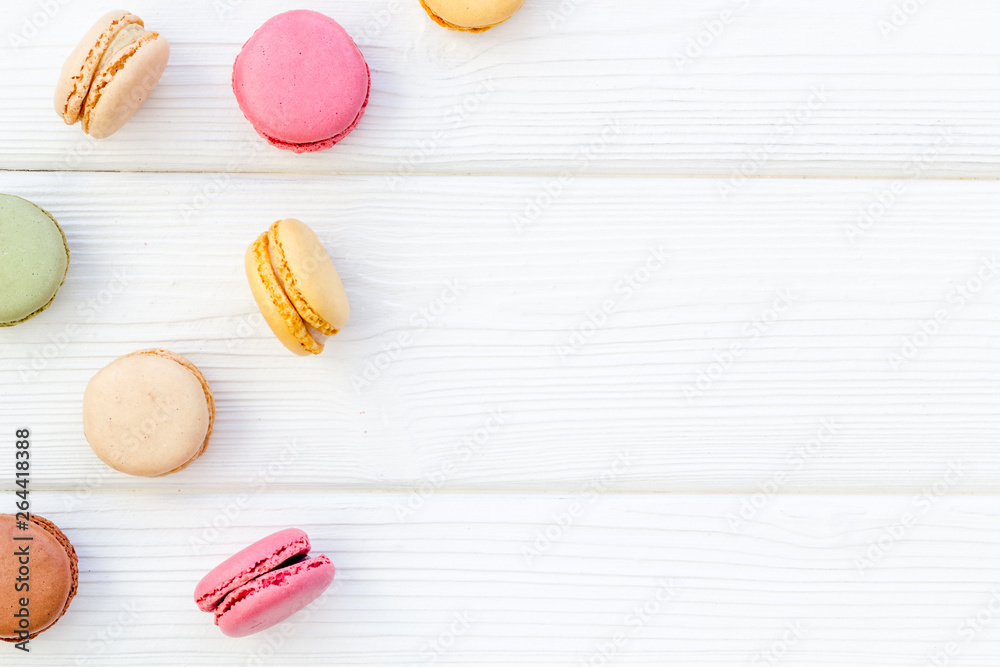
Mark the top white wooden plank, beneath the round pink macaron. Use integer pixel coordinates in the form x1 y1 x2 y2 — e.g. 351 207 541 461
0 0 1000 178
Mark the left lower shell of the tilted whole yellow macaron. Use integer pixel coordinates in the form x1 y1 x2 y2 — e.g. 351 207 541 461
244 232 323 356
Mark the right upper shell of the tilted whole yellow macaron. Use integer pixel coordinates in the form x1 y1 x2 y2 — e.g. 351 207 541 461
268 218 351 336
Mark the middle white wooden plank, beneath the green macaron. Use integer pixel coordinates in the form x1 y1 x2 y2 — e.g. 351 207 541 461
0 173 1000 493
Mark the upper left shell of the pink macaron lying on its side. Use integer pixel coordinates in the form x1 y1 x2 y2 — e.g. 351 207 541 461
194 528 310 611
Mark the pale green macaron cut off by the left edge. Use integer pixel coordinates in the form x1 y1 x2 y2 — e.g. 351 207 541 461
0 194 69 327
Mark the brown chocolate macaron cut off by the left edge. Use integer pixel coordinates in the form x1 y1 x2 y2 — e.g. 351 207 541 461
0 514 79 643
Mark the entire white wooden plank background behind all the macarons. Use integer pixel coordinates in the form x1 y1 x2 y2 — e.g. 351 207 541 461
0 0 1000 667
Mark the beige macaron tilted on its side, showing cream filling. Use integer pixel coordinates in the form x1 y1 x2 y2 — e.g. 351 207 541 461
55 9 170 139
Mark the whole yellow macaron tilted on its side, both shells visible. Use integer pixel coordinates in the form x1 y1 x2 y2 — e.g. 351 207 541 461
244 218 351 356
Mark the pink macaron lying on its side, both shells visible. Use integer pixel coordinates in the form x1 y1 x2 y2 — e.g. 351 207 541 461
194 528 334 637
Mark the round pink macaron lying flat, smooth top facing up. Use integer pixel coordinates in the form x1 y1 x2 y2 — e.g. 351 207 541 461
233 9 371 153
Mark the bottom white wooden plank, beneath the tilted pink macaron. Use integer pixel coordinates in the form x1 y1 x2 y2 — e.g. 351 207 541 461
11 492 1000 667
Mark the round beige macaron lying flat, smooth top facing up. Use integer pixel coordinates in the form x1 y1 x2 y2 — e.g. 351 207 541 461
83 350 215 477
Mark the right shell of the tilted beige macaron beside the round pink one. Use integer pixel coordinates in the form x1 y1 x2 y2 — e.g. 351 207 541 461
81 32 170 139
